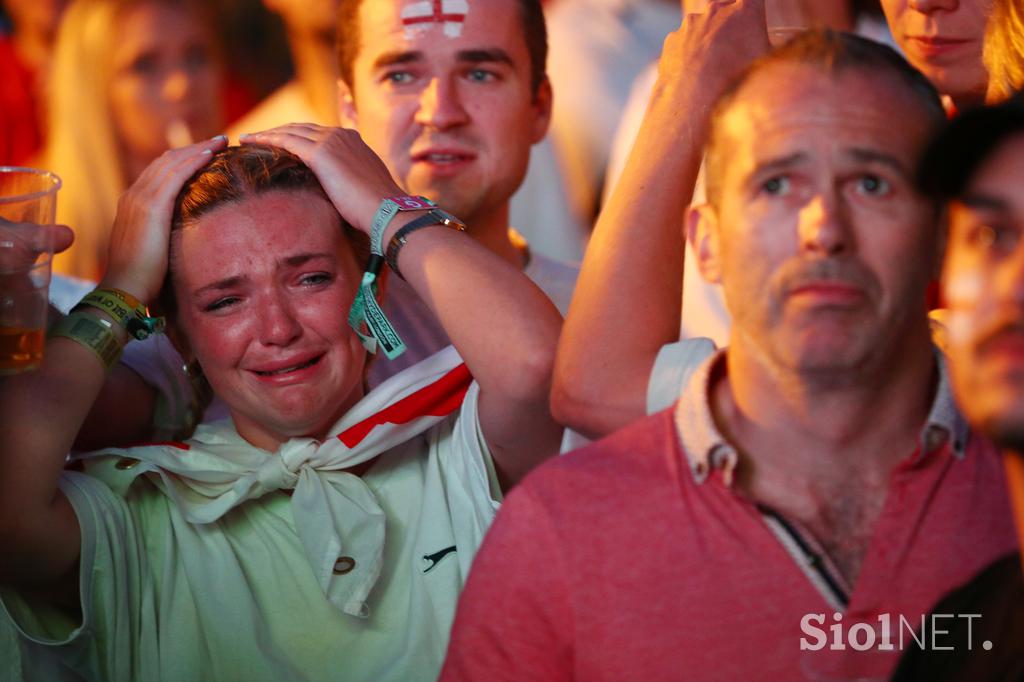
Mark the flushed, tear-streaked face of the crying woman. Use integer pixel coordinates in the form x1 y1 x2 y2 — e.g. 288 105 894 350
173 191 366 450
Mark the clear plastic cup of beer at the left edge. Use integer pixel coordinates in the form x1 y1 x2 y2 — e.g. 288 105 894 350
0 166 60 375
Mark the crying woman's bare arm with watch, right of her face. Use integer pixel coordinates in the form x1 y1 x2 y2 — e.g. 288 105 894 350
243 124 562 487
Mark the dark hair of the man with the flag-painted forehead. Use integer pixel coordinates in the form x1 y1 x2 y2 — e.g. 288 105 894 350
337 0 548 94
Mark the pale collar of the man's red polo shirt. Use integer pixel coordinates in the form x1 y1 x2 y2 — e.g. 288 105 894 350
674 347 969 485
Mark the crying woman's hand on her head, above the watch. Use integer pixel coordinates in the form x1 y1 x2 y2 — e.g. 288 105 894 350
242 123 406 235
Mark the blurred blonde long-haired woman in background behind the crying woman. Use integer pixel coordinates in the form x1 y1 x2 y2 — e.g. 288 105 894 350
42 0 222 281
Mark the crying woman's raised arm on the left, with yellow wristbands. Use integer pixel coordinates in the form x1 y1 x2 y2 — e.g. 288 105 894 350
0 140 224 589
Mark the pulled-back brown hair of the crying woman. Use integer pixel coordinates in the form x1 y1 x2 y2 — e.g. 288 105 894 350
158 144 370 319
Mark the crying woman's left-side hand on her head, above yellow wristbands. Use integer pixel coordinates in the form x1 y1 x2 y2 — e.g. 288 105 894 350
100 135 227 304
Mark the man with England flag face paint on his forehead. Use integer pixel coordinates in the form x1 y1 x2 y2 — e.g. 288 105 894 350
338 0 577 383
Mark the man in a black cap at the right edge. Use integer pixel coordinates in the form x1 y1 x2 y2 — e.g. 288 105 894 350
897 90 1024 680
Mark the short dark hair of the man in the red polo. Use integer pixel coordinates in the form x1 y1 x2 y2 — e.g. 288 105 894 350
706 29 946 205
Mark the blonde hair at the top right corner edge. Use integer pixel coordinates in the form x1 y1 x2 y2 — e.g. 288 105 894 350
984 0 1024 102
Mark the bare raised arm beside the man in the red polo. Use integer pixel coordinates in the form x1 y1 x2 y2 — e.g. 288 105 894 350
552 0 768 436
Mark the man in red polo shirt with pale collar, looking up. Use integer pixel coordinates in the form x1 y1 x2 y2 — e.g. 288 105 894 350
442 29 1016 680
